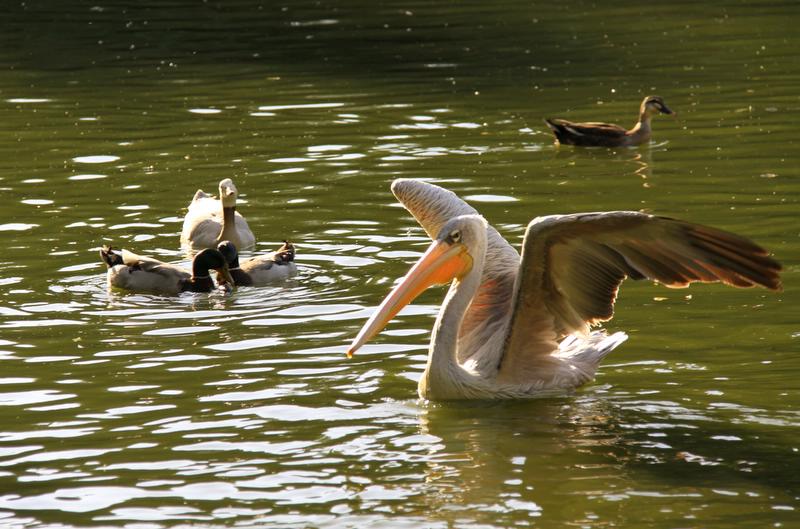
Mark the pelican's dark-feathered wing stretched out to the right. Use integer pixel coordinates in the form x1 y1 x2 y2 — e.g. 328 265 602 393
501 211 781 376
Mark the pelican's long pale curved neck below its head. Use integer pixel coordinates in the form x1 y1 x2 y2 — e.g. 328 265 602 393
418 238 486 400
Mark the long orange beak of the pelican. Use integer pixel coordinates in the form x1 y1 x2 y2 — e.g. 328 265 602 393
347 241 472 358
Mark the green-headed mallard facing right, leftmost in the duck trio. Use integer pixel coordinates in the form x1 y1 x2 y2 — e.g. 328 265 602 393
100 246 235 296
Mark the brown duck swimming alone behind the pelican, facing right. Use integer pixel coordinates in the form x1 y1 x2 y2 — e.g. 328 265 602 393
544 96 675 147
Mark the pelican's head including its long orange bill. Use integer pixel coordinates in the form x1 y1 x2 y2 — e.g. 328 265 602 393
347 215 487 357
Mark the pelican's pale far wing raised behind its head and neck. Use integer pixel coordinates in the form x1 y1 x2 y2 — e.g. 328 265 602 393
392 178 519 370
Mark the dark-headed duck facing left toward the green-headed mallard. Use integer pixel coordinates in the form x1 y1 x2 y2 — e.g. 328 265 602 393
217 241 297 287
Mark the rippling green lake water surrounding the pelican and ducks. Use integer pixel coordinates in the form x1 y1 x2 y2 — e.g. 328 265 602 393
0 0 800 529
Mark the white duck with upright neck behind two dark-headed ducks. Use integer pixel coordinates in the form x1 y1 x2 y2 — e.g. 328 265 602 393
181 178 256 250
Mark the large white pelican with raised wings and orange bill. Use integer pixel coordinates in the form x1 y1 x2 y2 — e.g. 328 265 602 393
347 179 781 400
